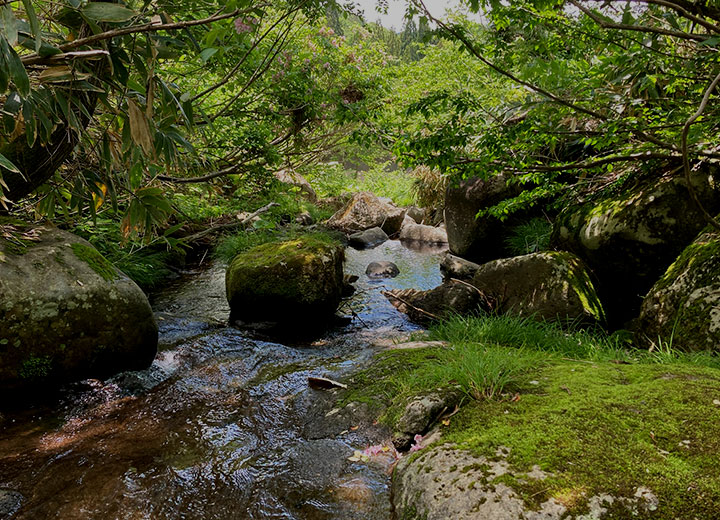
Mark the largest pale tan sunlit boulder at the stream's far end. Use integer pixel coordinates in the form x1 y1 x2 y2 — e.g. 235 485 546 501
327 192 405 235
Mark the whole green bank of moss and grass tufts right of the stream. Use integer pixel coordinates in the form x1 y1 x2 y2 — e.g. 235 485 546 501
344 317 720 519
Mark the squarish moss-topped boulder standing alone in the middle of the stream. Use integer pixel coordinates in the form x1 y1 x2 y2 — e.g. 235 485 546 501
225 235 344 322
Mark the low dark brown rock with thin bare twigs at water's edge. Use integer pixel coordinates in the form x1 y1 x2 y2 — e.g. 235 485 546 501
383 282 488 324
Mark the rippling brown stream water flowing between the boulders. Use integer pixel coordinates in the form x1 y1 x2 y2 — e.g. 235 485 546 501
0 241 448 520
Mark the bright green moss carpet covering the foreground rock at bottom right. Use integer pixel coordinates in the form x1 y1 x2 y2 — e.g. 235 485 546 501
446 363 720 518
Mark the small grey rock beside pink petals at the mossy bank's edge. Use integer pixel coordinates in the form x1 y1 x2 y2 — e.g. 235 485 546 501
393 390 461 450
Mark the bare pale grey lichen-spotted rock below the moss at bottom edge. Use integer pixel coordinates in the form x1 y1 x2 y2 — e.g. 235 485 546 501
392 445 567 520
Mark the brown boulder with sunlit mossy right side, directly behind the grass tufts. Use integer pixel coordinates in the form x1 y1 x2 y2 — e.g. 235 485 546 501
472 252 605 322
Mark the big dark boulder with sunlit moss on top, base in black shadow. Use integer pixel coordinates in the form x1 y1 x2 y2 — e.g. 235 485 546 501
551 170 720 327
